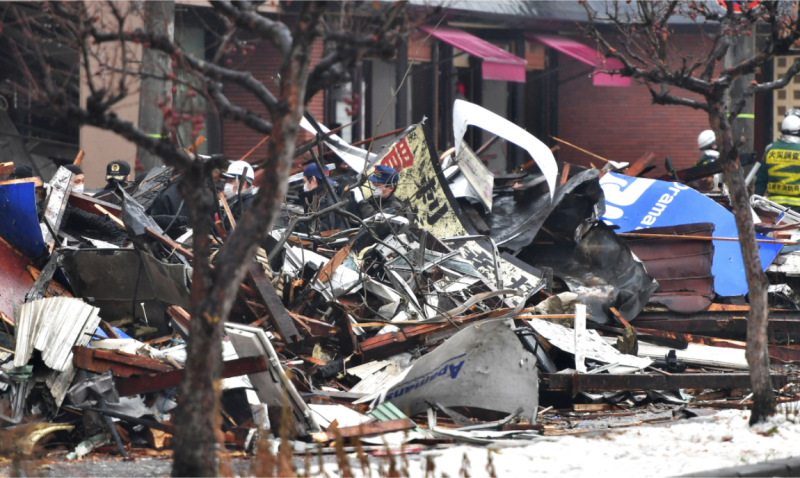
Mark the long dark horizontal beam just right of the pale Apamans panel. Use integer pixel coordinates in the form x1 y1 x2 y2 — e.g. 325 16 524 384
539 373 789 394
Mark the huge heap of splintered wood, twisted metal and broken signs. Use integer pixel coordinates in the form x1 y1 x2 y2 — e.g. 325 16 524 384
0 101 800 459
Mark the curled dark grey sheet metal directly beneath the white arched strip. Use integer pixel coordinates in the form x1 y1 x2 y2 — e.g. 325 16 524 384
484 169 603 252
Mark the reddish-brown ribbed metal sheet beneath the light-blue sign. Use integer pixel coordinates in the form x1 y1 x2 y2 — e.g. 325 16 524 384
623 223 714 314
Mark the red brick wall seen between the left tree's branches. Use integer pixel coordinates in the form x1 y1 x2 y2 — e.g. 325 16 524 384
222 34 324 161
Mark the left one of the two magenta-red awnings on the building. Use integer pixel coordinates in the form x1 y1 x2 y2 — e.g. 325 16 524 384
419 25 528 83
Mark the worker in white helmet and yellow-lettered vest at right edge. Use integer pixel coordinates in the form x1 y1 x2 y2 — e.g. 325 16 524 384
755 114 800 212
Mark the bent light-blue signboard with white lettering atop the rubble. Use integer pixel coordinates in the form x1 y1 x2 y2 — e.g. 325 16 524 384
600 173 781 296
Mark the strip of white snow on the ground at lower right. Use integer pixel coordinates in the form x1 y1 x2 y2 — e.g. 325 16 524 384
328 406 800 478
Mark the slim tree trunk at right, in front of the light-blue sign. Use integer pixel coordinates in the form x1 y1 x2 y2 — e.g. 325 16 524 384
709 107 775 425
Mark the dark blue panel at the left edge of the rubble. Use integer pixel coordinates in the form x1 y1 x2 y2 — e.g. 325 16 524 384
0 182 44 259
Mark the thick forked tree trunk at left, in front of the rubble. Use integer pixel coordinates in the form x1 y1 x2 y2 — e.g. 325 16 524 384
172 0 325 478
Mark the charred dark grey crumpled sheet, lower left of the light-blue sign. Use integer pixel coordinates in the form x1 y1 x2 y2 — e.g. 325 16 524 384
518 223 658 324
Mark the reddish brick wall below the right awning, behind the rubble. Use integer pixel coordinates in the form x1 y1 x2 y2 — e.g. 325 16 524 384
557 35 720 177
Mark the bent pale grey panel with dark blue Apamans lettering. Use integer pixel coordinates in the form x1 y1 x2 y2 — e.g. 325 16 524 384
380 320 539 419
